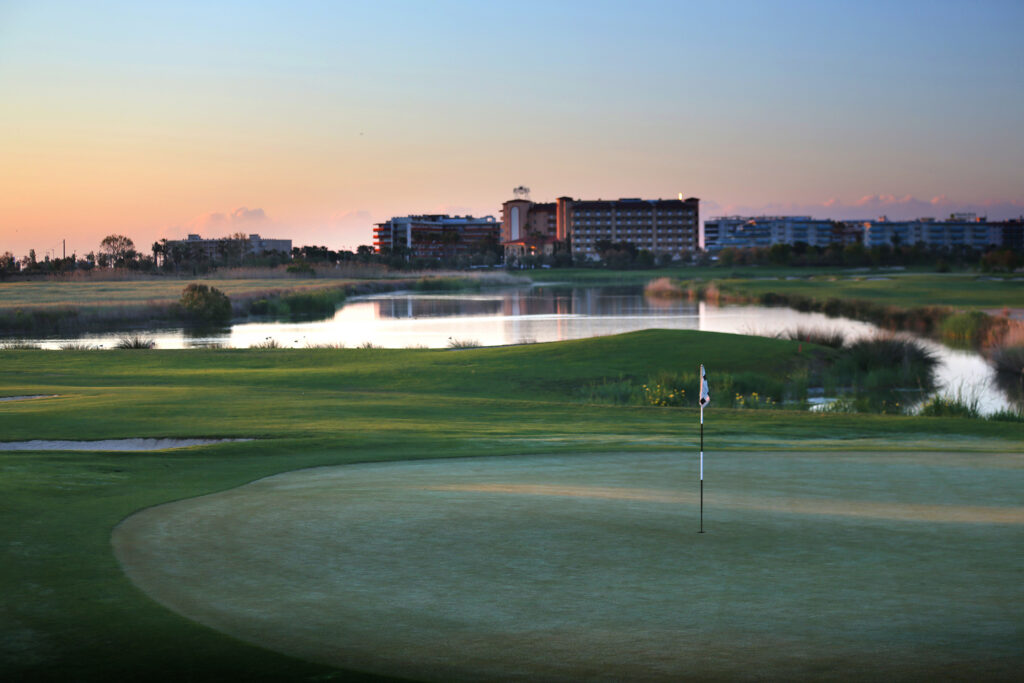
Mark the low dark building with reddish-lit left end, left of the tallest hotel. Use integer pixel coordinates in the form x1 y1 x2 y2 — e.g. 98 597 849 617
374 214 501 258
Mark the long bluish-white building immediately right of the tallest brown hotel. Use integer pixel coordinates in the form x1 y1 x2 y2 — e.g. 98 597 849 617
703 216 862 253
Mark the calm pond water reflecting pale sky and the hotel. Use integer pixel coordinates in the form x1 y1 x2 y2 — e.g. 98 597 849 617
24 285 1011 414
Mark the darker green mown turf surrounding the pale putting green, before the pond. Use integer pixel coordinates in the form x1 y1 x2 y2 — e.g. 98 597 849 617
0 331 1022 680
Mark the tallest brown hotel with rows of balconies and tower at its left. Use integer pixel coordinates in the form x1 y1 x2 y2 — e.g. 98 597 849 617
502 197 699 260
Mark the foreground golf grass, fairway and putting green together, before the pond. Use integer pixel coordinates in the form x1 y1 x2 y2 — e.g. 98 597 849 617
0 331 1024 680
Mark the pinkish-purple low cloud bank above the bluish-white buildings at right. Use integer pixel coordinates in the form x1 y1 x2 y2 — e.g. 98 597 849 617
700 195 1024 220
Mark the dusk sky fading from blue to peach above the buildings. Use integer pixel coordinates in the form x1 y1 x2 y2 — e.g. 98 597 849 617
0 0 1024 257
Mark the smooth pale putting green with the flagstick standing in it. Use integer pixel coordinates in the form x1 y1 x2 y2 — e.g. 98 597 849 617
113 453 1024 680
